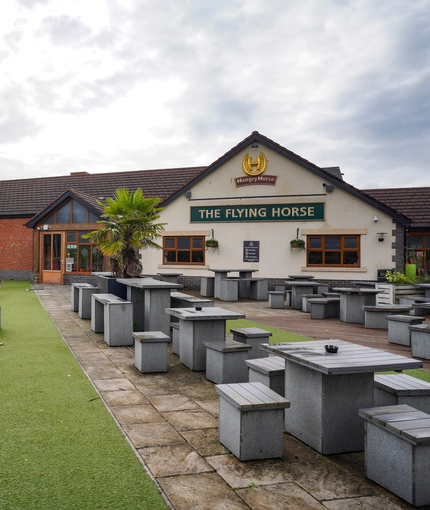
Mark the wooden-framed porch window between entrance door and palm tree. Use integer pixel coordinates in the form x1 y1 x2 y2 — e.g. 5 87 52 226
66 232 103 273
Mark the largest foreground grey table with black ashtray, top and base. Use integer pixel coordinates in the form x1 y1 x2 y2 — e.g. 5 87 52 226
261 339 423 455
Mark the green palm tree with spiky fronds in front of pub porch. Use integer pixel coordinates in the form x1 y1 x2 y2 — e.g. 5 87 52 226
84 188 165 278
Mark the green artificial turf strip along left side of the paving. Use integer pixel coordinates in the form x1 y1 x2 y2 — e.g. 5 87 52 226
0 281 168 510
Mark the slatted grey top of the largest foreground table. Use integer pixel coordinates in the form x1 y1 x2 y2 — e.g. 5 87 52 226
261 340 423 375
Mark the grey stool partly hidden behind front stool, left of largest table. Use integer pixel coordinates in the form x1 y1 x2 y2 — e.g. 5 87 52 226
245 356 285 397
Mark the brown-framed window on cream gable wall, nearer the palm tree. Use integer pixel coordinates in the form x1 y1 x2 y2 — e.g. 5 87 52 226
163 236 205 264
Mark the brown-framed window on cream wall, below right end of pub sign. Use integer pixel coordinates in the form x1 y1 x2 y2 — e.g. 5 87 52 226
307 236 360 267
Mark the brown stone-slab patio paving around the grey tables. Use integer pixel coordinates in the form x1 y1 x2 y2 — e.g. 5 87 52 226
35 285 430 510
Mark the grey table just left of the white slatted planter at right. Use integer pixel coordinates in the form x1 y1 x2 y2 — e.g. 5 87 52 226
333 287 382 324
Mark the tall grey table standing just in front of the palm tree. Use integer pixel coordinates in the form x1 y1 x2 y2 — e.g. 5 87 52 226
118 278 183 336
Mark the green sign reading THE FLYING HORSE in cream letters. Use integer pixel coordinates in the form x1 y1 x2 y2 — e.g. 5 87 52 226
191 203 324 223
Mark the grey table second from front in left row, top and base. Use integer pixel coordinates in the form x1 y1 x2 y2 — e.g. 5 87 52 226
165 306 245 371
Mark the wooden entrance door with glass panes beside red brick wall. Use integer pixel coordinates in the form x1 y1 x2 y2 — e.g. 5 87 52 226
40 232 64 285
